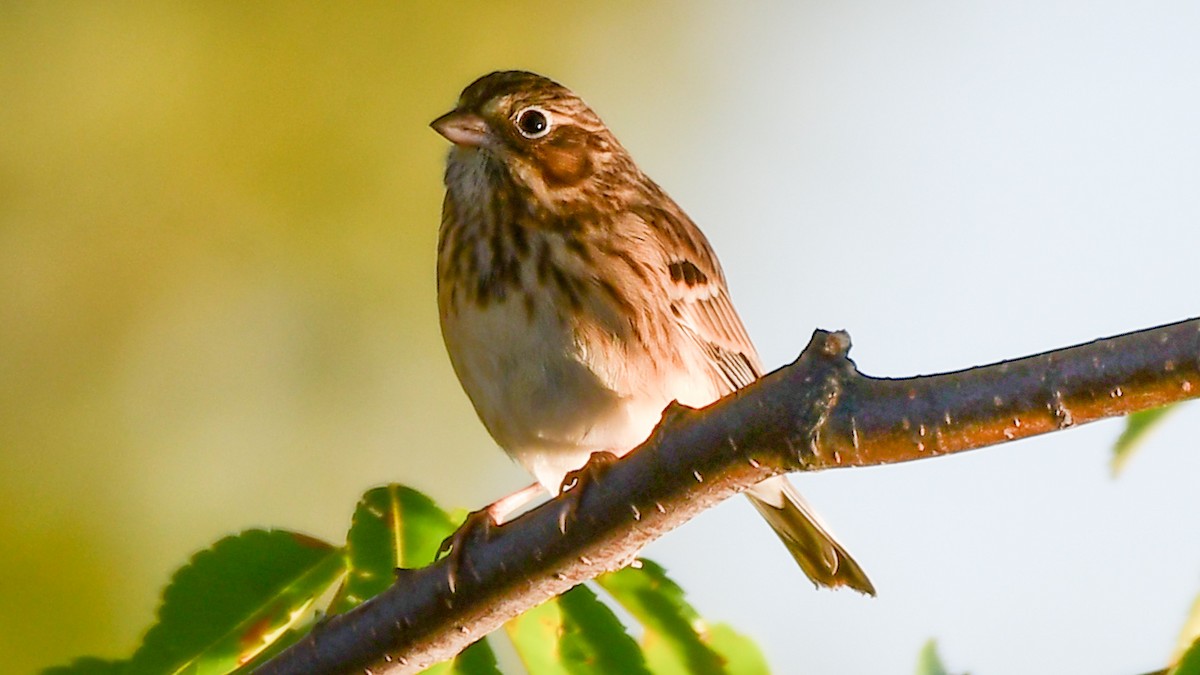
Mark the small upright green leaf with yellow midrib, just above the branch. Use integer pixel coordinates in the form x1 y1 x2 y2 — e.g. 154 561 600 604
330 484 455 614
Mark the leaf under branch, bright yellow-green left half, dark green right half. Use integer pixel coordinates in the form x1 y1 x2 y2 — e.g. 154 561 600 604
504 586 649 675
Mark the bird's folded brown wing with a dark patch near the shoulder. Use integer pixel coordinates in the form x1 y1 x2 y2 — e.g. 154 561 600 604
638 203 762 392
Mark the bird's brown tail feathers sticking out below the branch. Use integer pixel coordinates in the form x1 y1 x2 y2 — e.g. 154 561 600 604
746 477 875 596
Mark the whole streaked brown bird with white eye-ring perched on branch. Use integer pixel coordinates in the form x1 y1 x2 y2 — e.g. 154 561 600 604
432 71 875 595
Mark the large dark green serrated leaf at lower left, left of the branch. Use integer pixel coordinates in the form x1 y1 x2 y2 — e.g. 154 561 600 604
128 530 343 675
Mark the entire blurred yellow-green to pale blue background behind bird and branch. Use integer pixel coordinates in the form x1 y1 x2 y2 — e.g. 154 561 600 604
0 0 1200 674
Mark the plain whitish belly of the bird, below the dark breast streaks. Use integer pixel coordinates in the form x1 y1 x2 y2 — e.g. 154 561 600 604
442 293 674 492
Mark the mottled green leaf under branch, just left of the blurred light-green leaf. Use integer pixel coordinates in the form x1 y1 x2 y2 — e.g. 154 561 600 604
596 560 727 675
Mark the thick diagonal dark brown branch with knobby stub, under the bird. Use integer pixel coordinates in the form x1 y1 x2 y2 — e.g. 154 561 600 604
258 319 1200 675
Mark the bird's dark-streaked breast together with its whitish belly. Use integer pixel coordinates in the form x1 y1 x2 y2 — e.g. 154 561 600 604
438 186 715 489
